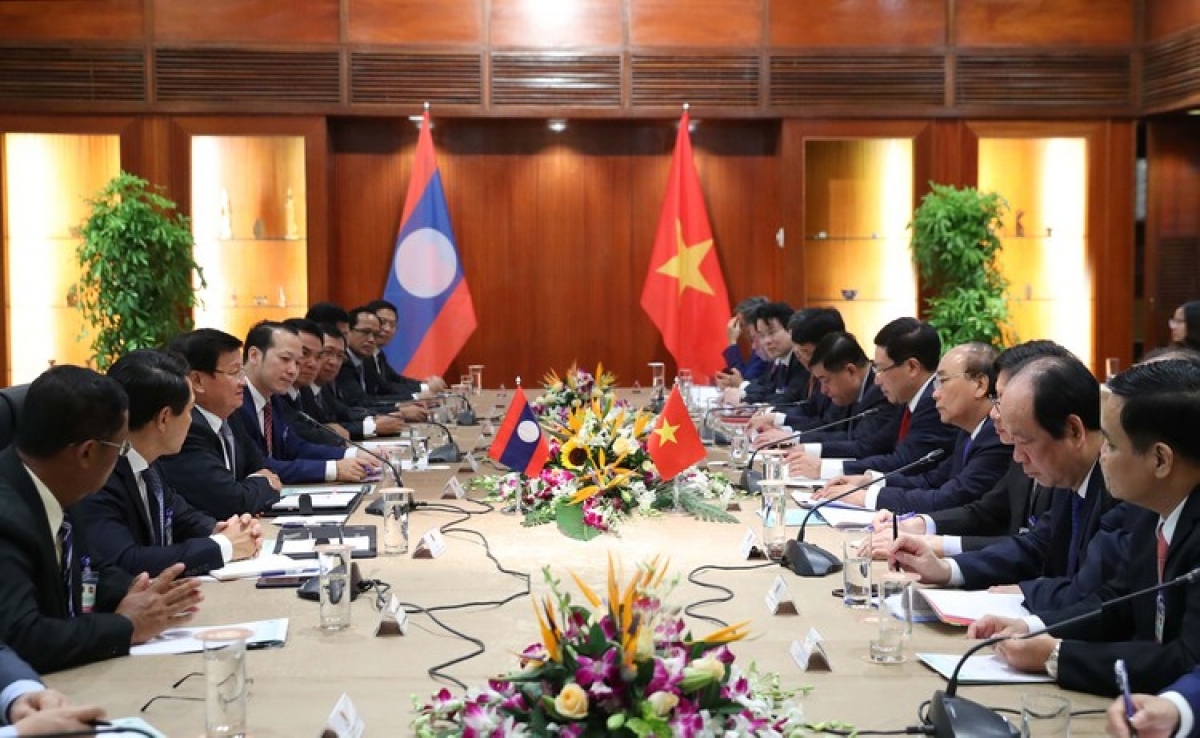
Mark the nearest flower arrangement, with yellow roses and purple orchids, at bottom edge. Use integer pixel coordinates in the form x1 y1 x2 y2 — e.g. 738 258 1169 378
413 557 815 738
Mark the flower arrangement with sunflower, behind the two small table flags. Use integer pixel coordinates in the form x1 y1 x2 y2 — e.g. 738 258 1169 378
470 394 737 540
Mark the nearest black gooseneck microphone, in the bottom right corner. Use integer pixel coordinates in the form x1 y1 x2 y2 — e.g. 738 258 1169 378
926 568 1200 738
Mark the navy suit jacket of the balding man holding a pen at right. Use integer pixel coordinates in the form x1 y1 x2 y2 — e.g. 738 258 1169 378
954 464 1114 589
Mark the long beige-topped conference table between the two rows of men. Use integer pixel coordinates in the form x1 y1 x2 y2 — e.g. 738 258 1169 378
47 398 1109 738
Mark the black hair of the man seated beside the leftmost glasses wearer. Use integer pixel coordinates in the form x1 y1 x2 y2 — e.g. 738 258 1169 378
108 348 192 431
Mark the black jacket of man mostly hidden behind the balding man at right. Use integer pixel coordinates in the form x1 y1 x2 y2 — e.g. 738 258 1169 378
930 460 1050 551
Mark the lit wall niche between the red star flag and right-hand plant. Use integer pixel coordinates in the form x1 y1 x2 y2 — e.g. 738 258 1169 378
804 138 917 340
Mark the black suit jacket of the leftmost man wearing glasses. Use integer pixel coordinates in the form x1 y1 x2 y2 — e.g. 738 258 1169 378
0 446 133 673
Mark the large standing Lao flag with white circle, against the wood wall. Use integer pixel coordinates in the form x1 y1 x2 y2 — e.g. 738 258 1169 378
383 110 475 377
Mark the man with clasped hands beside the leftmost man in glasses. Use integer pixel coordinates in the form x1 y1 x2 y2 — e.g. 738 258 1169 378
76 349 262 576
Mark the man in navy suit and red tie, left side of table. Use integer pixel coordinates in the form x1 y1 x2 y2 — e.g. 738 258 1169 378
239 320 376 484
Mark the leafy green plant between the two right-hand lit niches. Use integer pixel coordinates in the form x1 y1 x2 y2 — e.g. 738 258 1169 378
908 182 1008 348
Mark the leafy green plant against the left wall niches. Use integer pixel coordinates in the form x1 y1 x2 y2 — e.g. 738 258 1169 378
76 172 204 371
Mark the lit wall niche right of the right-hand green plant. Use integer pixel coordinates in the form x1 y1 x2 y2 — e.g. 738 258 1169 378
979 138 1096 364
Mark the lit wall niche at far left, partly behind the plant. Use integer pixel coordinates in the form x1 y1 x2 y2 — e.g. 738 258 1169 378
0 133 121 384
